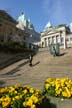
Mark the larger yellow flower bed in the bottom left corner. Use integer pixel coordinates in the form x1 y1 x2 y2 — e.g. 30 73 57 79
0 85 44 108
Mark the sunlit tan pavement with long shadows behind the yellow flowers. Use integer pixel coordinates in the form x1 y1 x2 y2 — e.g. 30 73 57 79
0 48 72 108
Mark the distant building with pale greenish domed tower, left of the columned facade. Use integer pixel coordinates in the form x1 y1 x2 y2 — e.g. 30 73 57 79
16 12 40 45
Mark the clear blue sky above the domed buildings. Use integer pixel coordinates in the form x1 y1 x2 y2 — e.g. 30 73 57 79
0 0 72 32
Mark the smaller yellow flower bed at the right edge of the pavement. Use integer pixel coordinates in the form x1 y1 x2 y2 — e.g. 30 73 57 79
43 78 72 98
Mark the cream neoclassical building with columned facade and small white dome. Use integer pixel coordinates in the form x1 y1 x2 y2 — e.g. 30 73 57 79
41 23 72 49
